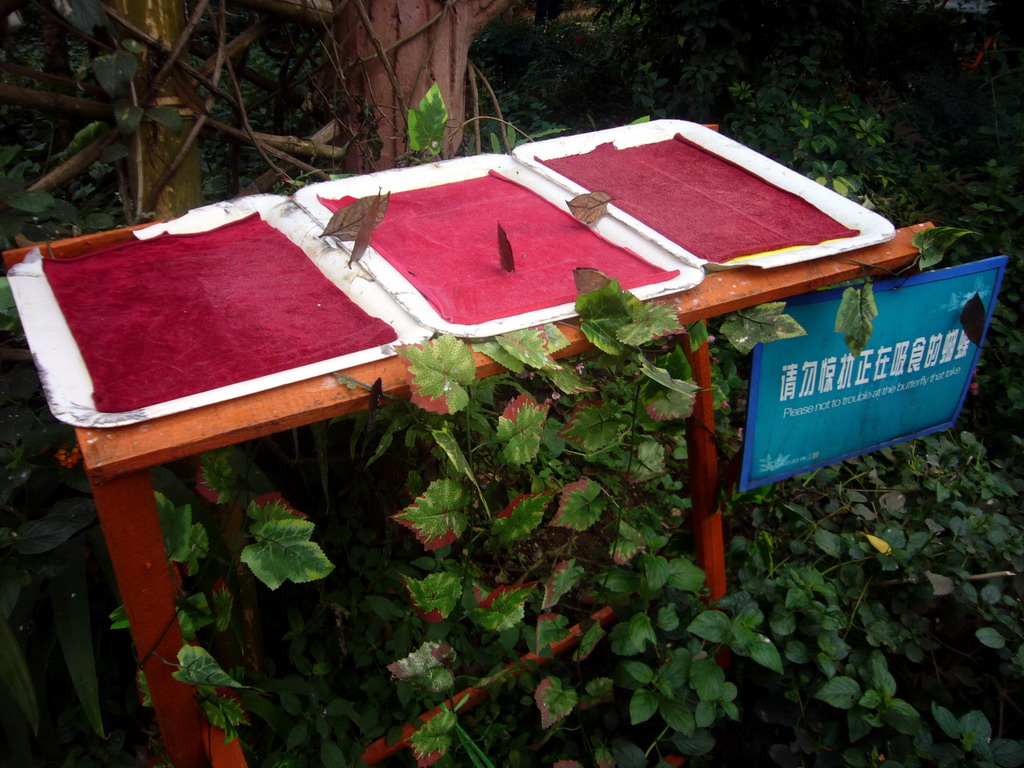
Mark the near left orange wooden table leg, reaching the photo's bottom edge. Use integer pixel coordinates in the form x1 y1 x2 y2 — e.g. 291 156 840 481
92 471 245 768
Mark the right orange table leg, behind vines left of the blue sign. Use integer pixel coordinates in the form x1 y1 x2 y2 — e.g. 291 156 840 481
683 329 725 602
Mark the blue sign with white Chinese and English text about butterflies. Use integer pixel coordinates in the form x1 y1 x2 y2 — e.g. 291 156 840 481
739 256 1007 490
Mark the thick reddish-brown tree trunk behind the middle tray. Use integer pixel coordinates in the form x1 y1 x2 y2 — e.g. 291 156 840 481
329 0 512 173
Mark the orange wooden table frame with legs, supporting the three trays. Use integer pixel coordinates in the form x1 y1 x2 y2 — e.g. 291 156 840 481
4 224 930 768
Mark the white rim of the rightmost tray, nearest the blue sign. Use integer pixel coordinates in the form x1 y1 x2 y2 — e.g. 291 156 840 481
512 120 896 271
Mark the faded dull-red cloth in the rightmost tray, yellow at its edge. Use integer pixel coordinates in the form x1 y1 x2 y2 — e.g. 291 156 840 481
541 135 859 263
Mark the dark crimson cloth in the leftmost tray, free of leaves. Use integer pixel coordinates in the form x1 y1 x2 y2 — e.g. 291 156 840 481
43 215 397 413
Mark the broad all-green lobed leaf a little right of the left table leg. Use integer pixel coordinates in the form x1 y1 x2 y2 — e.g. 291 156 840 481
242 517 334 590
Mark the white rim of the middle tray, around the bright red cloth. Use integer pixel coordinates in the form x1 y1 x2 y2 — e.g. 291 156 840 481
295 155 703 338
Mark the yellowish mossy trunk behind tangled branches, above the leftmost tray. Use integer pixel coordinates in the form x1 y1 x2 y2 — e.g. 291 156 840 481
111 0 203 219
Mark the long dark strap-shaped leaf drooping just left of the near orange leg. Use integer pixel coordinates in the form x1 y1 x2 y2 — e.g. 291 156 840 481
50 537 106 738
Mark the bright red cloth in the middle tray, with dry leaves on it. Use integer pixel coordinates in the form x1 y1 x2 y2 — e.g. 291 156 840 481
321 173 679 325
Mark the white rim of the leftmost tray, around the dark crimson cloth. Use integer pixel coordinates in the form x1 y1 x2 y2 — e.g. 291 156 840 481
8 195 431 427
